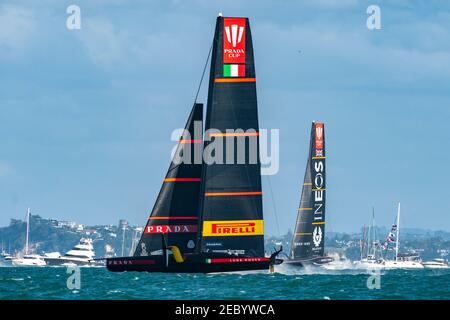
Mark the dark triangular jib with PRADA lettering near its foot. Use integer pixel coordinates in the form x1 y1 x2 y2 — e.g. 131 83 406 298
134 103 203 256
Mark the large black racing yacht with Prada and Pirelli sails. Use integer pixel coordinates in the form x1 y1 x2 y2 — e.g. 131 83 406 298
106 16 282 273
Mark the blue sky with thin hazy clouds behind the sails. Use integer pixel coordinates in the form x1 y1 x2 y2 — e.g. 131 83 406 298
0 0 450 235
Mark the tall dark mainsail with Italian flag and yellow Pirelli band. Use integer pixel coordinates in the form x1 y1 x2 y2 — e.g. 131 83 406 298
200 17 264 257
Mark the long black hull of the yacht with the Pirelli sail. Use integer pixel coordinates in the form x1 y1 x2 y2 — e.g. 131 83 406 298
106 256 283 273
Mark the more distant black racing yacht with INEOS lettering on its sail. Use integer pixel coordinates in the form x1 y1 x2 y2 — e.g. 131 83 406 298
285 122 334 266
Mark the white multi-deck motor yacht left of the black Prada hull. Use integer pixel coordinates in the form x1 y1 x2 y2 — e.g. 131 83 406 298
43 238 99 266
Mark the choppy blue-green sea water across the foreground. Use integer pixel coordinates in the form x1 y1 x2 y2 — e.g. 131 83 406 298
0 267 450 300
